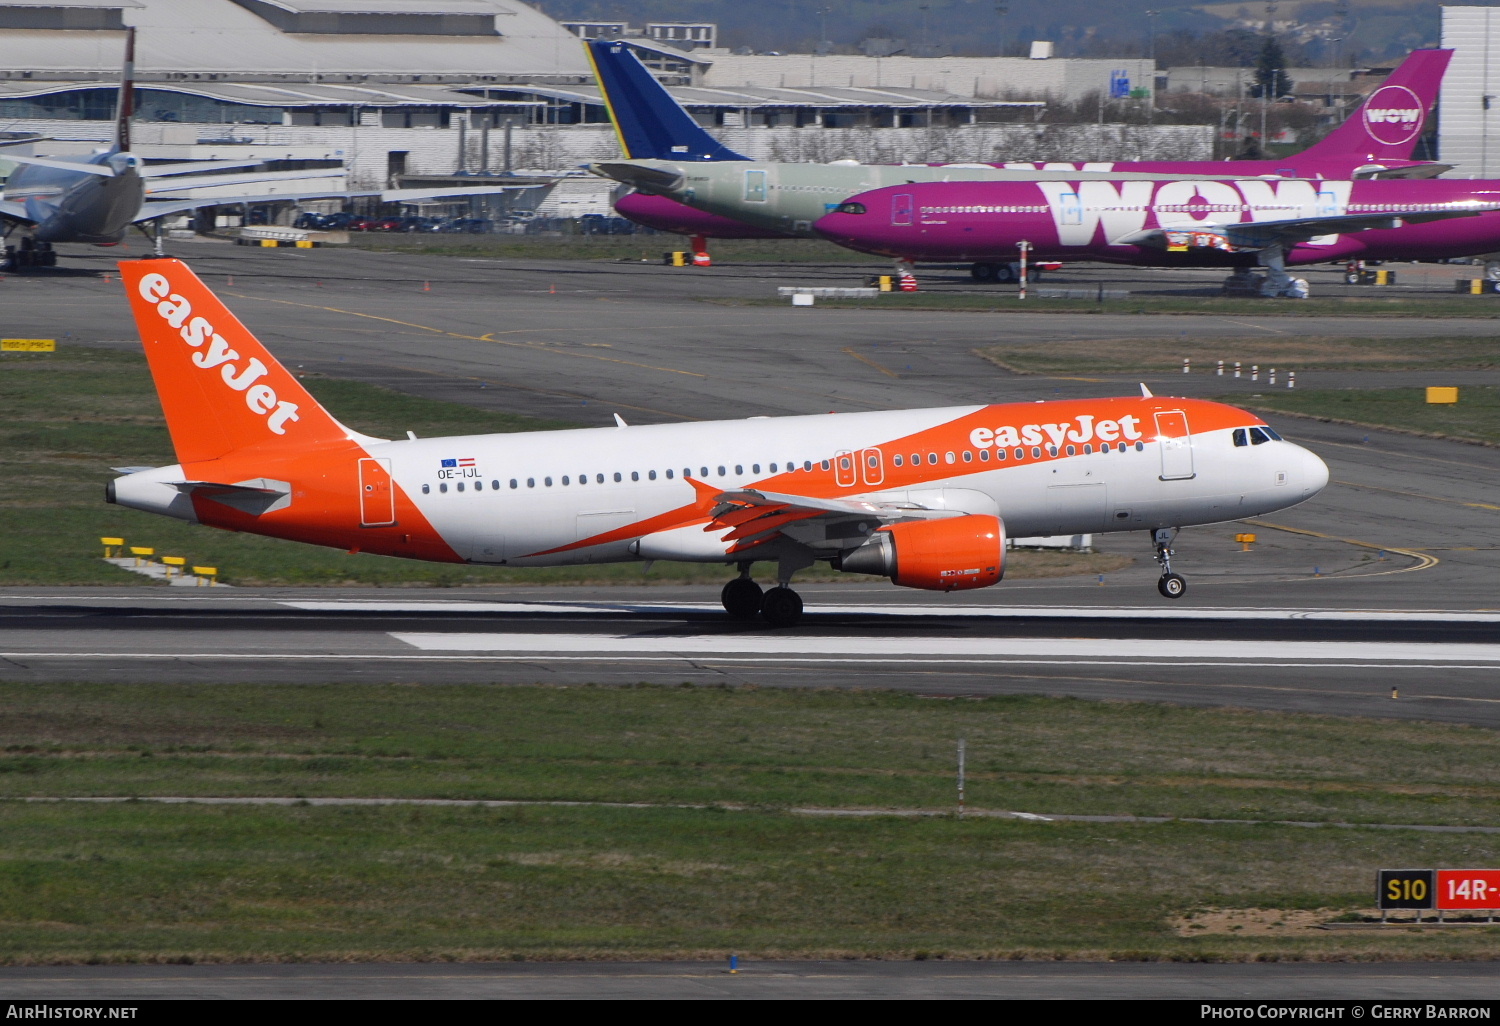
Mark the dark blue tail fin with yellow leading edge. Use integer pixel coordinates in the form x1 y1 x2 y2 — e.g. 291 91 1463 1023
584 39 750 162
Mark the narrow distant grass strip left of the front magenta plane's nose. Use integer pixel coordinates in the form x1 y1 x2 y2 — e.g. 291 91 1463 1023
350 233 890 266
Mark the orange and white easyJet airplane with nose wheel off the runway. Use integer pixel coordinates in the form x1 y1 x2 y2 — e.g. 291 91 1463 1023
108 260 1328 627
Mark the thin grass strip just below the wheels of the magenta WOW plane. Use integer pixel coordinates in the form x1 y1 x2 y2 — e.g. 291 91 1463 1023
732 292 1500 318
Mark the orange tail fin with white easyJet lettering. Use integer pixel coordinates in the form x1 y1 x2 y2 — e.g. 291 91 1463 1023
120 260 353 464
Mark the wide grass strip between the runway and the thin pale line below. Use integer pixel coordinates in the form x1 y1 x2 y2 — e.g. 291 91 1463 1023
0 684 1500 828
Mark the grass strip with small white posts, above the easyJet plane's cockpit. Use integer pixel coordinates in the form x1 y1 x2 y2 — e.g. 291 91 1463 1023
980 332 1500 380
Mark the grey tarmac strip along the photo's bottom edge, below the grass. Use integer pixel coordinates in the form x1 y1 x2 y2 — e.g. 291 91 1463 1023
0 960 1500 1017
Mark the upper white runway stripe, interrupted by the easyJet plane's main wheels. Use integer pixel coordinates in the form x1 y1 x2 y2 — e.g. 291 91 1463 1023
278 599 1500 624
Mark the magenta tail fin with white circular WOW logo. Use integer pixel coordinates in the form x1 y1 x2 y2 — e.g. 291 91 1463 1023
1301 50 1454 161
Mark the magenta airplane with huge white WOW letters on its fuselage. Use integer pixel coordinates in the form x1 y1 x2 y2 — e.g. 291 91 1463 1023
816 179 1500 299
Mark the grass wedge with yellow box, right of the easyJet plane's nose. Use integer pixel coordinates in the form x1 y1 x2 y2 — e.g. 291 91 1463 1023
1233 378 1500 443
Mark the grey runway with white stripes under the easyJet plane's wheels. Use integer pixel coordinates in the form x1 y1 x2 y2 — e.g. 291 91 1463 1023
0 585 1500 726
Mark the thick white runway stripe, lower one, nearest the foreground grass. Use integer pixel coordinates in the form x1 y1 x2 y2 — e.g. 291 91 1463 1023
390 633 1500 666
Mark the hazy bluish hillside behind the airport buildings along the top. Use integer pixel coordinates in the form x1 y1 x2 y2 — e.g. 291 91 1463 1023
534 0 1452 66
